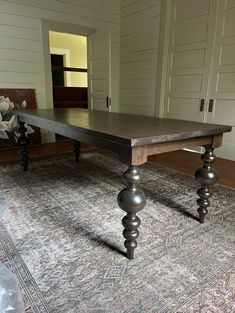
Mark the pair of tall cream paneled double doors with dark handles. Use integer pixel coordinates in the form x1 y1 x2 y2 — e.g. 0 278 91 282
164 0 235 160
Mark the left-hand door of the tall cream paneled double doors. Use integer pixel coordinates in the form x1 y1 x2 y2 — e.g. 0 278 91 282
165 0 217 122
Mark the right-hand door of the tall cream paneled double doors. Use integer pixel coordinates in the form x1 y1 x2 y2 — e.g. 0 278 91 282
207 0 235 160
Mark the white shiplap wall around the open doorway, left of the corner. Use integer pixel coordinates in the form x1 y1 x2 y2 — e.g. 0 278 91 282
0 0 120 118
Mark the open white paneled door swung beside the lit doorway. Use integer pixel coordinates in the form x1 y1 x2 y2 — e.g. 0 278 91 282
88 31 111 111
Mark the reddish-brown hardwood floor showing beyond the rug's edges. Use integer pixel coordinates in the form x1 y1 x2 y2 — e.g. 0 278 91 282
0 140 235 189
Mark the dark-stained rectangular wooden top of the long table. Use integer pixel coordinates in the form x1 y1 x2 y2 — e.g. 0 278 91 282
13 109 232 146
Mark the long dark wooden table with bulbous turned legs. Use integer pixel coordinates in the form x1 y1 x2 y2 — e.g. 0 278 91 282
14 109 232 259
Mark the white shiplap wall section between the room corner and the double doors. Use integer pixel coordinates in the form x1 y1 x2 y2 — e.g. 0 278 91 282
119 0 161 116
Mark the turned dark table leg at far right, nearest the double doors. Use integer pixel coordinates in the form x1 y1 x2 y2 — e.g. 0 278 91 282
195 145 219 223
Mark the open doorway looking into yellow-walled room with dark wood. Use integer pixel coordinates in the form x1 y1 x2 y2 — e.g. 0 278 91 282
49 31 88 109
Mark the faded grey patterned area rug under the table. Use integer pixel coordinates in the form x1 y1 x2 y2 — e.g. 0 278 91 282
0 152 235 313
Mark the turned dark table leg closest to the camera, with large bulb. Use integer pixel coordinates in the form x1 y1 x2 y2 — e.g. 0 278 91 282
117 166 146 259
